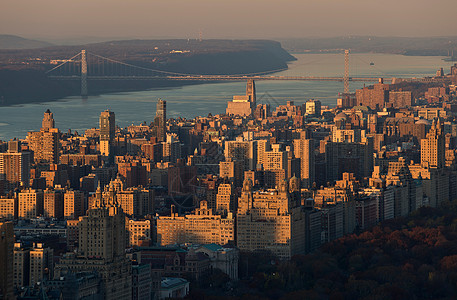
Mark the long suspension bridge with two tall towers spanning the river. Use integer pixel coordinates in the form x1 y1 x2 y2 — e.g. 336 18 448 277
46 50 418 96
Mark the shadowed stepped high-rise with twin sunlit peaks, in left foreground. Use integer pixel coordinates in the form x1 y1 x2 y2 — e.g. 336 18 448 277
55 186 132 299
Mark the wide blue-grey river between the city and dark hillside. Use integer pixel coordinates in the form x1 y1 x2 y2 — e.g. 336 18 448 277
0 53 450 141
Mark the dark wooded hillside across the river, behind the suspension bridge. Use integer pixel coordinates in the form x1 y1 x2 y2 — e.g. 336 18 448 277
0 40 295 105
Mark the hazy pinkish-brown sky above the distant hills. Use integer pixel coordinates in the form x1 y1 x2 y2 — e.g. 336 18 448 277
0 0 457 38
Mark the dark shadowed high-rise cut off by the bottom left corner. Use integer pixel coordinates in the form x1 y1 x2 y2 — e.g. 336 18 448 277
0 222 15 299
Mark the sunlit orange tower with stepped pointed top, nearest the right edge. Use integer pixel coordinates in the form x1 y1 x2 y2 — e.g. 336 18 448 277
421 118 446 168
